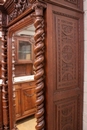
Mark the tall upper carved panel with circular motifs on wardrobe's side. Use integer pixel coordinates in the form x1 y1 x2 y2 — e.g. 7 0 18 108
54 12 79 91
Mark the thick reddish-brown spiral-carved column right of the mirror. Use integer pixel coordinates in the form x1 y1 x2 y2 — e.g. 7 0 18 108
34 2 45 130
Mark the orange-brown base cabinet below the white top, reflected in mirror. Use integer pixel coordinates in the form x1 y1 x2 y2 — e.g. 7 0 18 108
14 81 36 120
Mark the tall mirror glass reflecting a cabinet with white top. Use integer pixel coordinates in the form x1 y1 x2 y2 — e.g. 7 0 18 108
12 24 36 130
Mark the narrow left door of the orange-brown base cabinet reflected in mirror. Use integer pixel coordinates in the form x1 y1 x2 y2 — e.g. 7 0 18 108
15 86 21 119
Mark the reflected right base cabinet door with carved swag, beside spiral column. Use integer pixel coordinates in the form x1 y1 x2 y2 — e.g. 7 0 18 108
22 83 36 116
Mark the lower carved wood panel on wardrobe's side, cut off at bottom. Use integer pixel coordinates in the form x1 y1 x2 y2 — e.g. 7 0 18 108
55 96 80 130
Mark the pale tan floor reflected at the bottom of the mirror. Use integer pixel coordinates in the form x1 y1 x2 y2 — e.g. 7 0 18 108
17 116 36 130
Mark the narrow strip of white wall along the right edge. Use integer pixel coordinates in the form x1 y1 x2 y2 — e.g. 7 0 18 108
83 0 87 130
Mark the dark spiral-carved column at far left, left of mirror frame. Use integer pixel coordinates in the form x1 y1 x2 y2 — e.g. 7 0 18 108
2 29 9 130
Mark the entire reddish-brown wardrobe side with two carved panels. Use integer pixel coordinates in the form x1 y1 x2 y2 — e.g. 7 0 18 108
46 5 84 130
